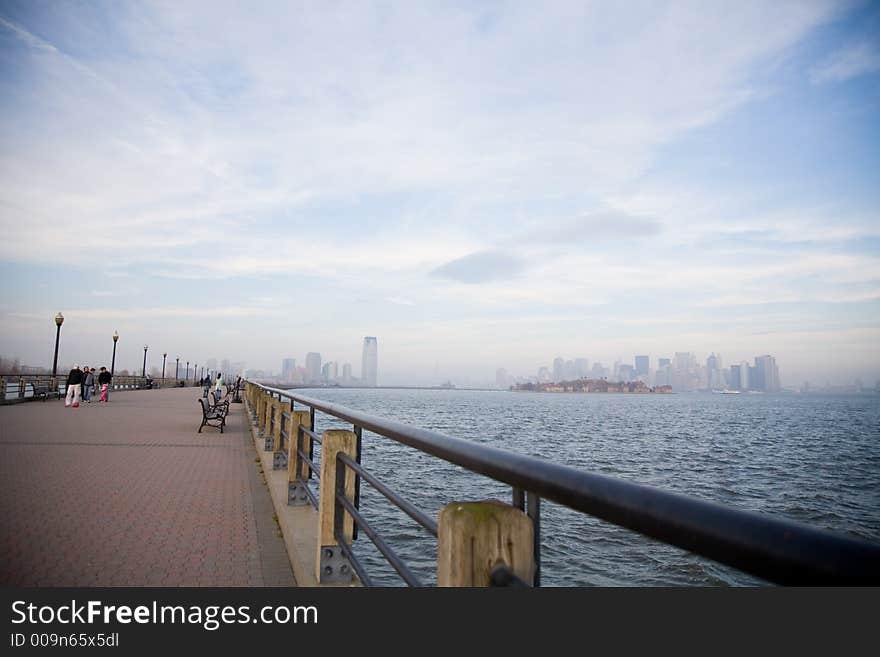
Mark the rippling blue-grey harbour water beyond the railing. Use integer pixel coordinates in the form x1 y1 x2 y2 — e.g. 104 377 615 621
286 389 880 586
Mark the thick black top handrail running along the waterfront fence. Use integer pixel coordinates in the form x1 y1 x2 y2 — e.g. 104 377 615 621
251 382 880 585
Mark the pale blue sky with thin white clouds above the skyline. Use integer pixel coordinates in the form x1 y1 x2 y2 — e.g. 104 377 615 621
0 0 880 386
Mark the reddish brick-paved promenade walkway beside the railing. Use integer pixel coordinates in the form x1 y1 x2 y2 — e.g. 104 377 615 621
0 388 295 586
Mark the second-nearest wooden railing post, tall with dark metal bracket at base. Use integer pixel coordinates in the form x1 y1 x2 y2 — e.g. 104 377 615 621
315 429 357 584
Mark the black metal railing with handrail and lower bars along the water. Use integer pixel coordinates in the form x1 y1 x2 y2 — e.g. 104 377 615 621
251 383 880 586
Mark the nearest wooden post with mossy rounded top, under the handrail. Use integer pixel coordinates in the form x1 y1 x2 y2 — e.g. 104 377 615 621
437 500 535 587
